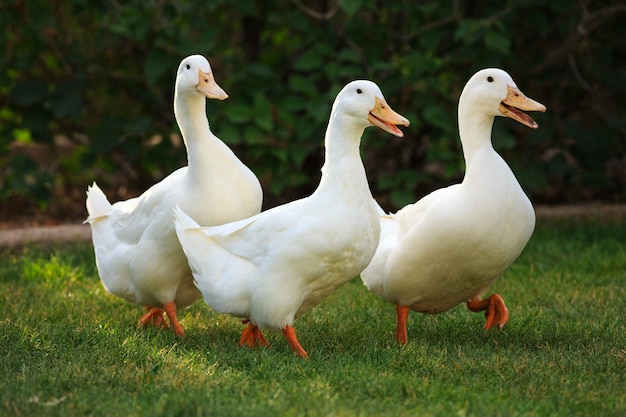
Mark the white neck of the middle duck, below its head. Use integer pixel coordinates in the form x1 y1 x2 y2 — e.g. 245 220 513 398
318 115 369 192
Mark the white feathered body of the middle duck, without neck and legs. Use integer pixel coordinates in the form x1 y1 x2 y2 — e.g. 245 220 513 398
177 160 380 329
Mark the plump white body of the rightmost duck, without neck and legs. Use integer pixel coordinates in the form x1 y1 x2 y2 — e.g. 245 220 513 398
372 152 535 313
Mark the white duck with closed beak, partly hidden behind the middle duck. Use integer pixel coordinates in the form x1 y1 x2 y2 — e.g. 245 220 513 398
86 55 263 337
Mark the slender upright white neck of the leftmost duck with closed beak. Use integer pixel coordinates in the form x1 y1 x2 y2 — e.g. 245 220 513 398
174 94 216 175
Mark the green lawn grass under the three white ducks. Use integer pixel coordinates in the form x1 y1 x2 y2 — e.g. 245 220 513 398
0 220 626 417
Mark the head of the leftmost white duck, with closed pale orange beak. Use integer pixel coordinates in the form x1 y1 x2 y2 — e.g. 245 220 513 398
176 55 228 100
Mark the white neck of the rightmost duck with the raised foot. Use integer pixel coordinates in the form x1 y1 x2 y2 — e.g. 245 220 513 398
459 106 495 181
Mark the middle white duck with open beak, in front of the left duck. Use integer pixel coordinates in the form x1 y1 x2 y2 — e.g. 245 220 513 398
175 80 409 357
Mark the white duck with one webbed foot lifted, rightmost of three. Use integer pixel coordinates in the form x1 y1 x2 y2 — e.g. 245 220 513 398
361 68 546 343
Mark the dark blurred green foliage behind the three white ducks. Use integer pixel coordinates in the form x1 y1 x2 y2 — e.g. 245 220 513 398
0 0 626 209
